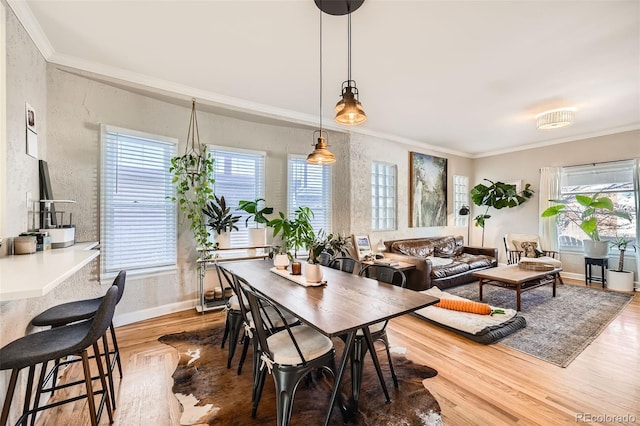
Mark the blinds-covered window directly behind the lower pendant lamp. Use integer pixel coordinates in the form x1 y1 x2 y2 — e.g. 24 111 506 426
287 155 331 235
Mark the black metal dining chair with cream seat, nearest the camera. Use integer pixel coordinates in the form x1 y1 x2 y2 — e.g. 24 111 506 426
242 285 342 426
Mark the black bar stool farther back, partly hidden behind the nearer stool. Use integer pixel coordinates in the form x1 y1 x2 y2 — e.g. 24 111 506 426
31 271 127 410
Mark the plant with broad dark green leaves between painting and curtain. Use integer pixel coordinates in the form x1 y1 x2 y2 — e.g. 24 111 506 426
467 179 533 246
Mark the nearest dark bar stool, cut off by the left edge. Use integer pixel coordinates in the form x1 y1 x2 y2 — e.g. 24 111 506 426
0 286 118 426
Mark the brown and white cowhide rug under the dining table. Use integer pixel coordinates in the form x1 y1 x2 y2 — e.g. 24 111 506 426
158 326 442 426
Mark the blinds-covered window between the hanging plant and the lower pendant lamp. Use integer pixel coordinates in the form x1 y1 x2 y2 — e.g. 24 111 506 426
210 146 265 247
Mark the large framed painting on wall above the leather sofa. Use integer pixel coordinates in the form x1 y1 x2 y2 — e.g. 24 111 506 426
409 152 447 228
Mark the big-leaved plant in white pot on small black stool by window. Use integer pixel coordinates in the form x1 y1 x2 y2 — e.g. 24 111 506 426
542 193 631 258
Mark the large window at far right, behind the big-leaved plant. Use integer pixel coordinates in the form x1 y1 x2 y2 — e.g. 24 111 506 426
557 161 637 250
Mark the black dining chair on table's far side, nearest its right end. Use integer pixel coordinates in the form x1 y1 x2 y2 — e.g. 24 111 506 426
351 264 407 391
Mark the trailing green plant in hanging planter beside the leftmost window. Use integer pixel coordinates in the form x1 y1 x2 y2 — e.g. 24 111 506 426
169 147 215 256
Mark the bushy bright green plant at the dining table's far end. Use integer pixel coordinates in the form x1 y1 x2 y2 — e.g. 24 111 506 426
269 206 316 259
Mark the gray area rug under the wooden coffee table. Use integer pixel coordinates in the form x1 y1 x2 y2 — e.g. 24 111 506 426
446 282 633 367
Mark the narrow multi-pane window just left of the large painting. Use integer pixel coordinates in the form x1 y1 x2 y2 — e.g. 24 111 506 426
371 161 396 231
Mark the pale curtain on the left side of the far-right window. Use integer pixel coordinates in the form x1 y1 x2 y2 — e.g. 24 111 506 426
538 167 562 251
